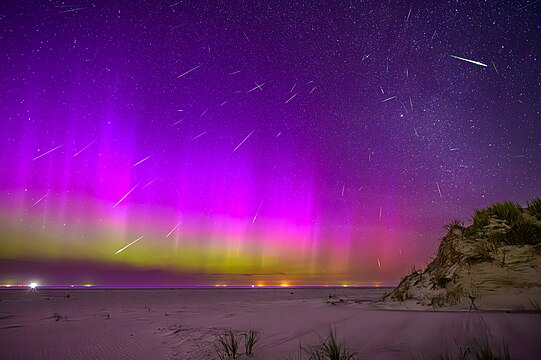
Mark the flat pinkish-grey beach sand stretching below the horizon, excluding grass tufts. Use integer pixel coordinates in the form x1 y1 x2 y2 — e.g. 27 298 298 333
0 288 541 360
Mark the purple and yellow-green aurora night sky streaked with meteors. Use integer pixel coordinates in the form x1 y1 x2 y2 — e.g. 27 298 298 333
0 0 541 285
